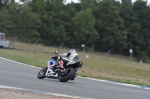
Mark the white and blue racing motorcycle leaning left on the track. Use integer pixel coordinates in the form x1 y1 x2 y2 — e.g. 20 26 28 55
37 51 83 82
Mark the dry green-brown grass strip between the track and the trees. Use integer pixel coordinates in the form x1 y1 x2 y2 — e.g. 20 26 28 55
0 43 150 86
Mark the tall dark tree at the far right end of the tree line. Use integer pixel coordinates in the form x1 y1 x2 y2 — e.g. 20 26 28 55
133 0 150 58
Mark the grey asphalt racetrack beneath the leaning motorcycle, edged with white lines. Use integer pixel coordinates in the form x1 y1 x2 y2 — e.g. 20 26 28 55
0 58 150 99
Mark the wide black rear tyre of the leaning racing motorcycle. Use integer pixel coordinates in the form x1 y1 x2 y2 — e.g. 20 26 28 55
59 68 76 82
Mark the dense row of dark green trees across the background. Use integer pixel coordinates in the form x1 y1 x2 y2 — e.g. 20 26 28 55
0 0 150 61
